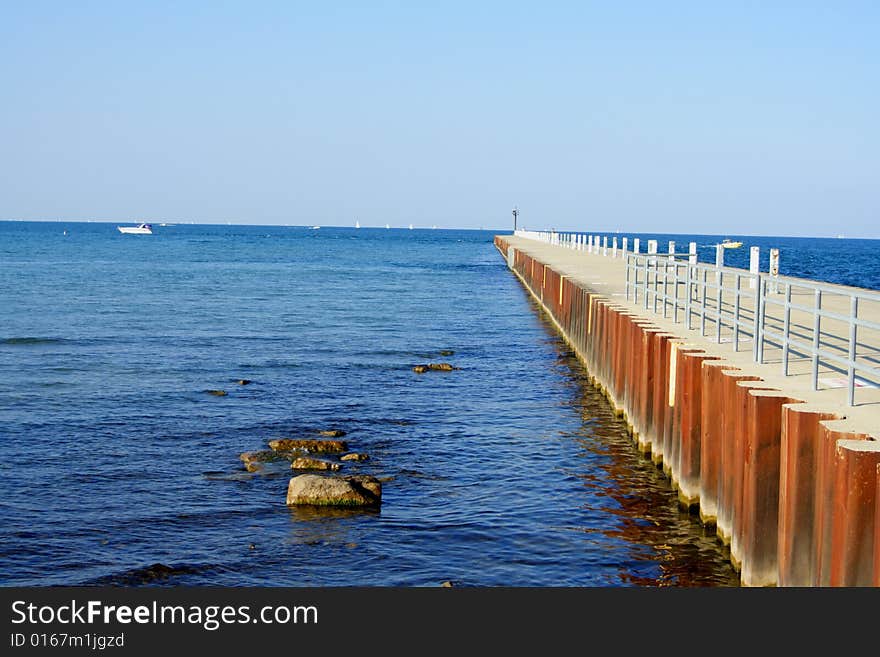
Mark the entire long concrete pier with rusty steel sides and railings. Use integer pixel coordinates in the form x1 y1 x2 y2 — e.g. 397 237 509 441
495 231 880 586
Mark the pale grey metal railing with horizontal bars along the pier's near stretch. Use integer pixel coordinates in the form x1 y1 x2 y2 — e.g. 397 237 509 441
625 253 880 406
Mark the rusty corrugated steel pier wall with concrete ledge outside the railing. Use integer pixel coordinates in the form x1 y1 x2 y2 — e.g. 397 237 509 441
495 235 880 586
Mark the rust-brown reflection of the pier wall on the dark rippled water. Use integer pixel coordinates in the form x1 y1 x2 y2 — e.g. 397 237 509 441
536 307 740 587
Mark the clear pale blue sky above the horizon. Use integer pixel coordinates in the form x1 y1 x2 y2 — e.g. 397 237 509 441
0 0 880 237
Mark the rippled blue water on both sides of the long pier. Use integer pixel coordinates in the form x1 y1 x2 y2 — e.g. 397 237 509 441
0 221 880 587
